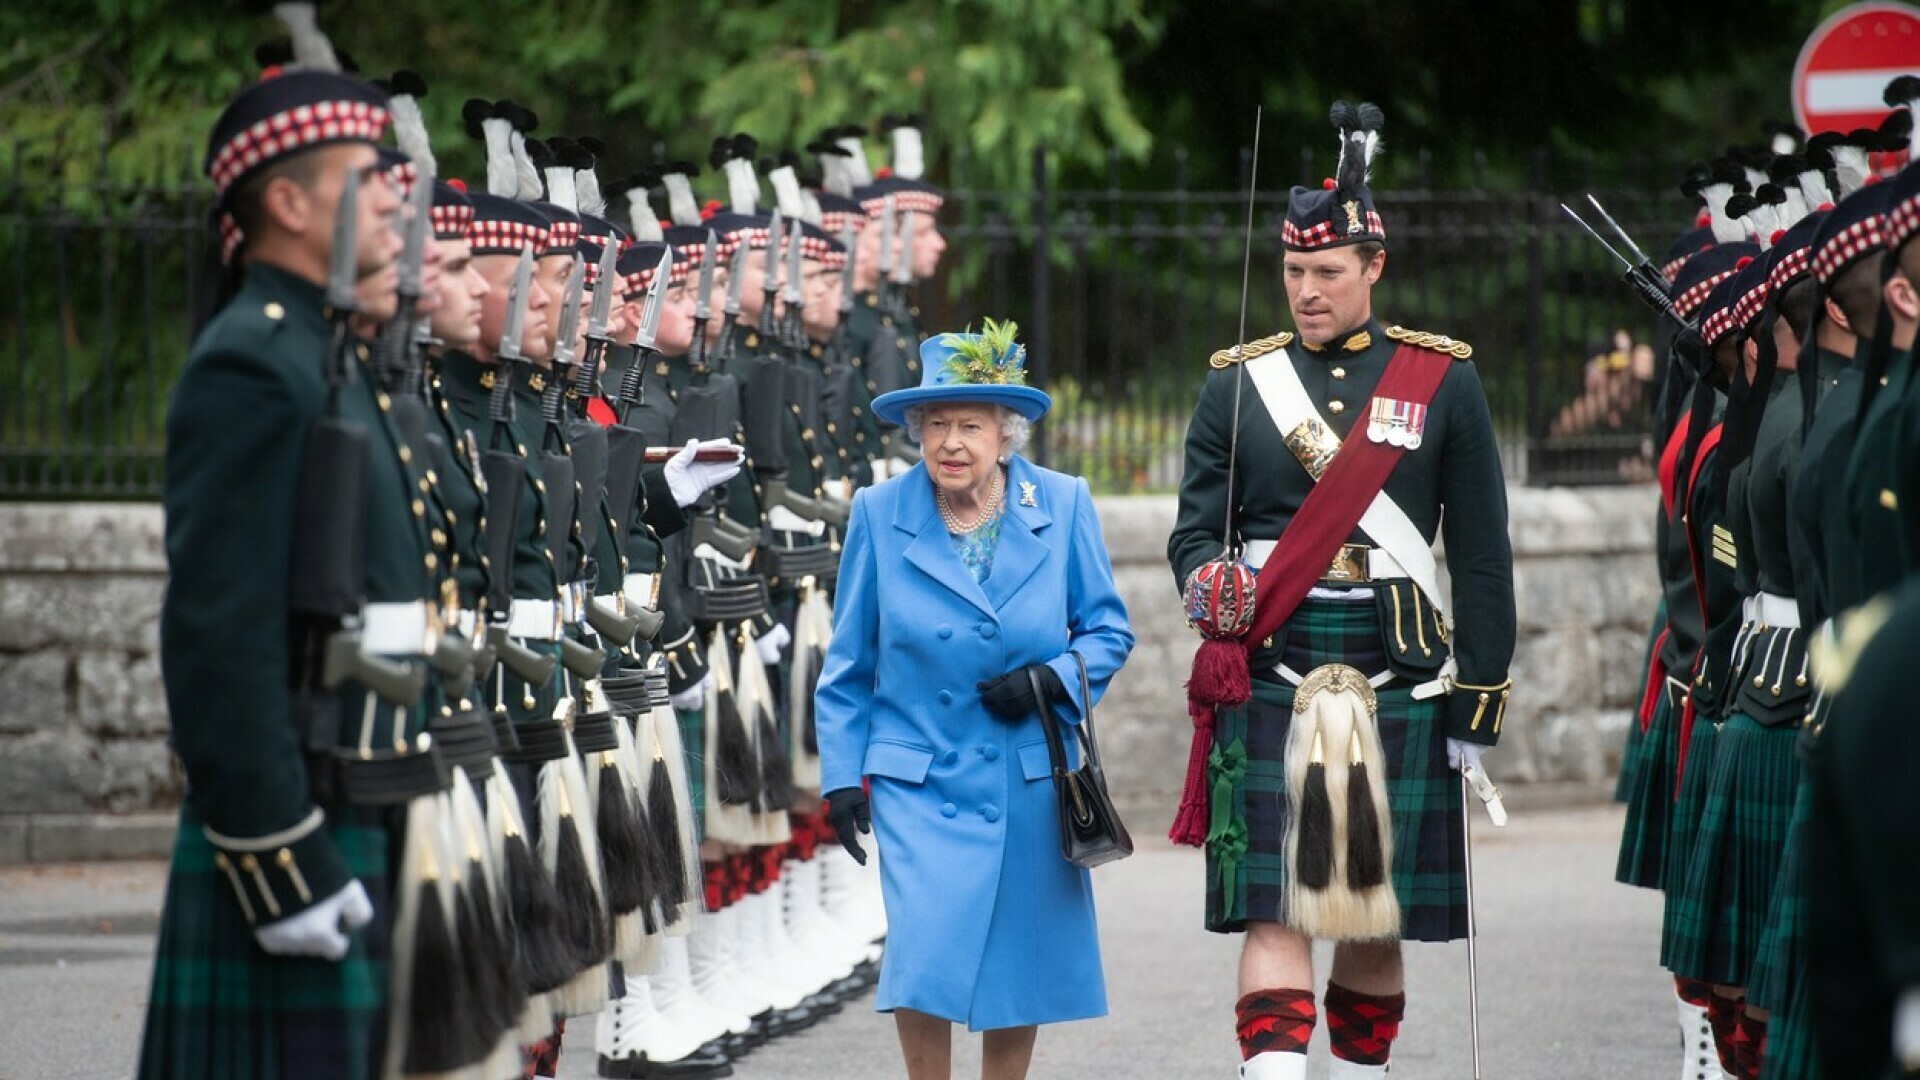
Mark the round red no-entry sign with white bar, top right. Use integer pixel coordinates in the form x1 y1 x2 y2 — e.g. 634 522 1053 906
1793 4 1920 135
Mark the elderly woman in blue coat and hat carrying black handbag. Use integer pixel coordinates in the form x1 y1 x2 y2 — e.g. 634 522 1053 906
816 321 1133 1080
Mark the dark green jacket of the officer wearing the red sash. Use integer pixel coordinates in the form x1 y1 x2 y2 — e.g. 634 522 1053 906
1167 321 1515 744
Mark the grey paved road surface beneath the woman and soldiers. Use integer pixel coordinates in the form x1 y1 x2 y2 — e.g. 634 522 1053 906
0 807 1678 1080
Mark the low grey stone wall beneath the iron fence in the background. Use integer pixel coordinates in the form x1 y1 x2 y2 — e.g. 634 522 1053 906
0 486 1659 849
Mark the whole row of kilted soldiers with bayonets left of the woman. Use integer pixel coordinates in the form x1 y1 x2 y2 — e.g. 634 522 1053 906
140 4 945 1078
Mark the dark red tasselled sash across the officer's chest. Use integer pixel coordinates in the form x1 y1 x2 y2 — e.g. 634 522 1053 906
1167 344 1453 847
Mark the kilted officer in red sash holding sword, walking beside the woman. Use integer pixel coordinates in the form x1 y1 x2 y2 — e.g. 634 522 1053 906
1167 102 1515 1080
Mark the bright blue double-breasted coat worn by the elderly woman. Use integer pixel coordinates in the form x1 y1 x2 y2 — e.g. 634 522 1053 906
814 457 1133 1030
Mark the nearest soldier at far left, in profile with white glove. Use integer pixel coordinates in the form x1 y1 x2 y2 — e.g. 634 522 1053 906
138 54 428 1078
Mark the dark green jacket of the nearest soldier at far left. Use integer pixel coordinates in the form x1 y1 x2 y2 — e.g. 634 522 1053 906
159 263 434 922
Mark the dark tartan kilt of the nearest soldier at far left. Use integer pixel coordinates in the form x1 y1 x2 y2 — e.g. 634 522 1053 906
138 805 399 1080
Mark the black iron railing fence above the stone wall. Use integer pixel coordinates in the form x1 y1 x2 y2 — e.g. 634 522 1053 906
0 141 1686 500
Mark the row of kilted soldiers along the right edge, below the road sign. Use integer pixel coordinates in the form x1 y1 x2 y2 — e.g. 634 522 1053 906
1617 77 1920 1080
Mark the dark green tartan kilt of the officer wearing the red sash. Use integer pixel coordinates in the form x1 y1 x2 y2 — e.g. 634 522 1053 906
1206 598 1467 942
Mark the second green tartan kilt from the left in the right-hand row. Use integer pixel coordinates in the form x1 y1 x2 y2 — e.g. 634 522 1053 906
1672 713 1799 986
